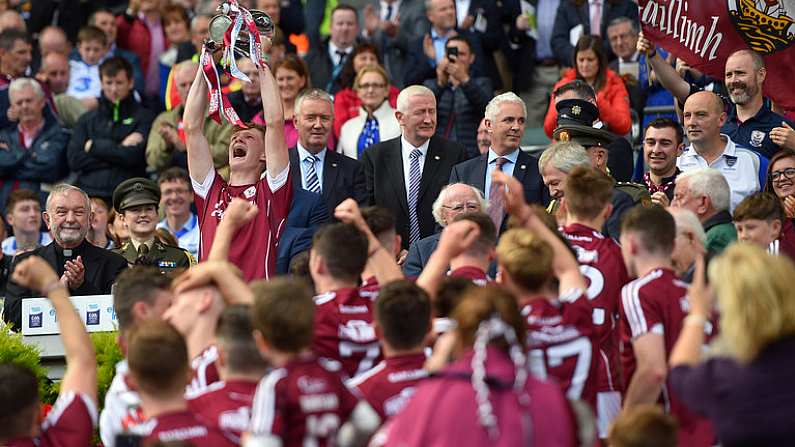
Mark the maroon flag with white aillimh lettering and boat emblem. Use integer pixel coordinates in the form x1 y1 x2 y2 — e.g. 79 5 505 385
638 0 795 110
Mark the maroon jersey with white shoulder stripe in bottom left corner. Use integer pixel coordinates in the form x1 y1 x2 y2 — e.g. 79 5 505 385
3 392 97 447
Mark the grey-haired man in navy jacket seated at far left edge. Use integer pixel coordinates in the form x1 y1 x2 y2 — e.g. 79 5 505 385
0 78 69 210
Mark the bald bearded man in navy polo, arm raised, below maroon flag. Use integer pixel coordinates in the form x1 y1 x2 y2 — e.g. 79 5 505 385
638 36 795 158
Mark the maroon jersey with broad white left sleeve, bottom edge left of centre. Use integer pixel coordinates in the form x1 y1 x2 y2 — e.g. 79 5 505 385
251 356 358 447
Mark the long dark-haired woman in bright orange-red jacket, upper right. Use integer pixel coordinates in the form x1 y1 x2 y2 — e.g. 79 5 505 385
544 35 632 138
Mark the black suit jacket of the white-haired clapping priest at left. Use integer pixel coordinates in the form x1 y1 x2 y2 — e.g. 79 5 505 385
3 241 127 330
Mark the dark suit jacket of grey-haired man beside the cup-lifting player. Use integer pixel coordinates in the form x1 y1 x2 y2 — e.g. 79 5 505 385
288 147 367 213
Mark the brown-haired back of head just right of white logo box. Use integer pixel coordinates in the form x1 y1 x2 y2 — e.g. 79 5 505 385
113 266 171 332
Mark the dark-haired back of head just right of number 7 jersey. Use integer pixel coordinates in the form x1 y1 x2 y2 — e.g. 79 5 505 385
375 280 431 350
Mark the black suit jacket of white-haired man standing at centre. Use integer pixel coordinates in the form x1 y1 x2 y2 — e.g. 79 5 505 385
362 136 466 248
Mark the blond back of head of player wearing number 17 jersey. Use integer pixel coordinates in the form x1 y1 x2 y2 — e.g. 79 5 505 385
497 228 554 292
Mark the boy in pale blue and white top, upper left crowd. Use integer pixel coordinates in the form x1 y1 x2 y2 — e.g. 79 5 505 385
66 25 108 109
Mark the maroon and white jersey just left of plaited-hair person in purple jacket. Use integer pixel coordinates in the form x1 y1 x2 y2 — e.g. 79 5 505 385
347 353 428 421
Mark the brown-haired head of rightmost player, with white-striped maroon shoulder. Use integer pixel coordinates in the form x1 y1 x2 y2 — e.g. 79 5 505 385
621 205 676 256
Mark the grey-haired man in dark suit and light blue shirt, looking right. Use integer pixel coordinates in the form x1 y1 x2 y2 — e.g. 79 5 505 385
450 92 545 232
